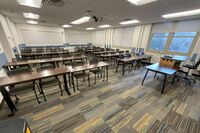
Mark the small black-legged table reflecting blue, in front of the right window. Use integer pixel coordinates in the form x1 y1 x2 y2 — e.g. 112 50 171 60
142 63 177 94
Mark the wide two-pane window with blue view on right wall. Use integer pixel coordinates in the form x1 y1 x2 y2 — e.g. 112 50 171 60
148 32 197 54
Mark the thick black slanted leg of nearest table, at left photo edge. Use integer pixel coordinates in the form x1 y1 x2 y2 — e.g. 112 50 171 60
0 87 17 115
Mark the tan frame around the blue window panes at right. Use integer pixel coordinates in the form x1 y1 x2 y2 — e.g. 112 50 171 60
147 31 200 56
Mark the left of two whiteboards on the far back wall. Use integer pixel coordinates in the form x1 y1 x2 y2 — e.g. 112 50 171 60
21 29 64 45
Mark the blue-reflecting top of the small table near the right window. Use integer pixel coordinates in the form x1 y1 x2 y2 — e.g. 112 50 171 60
146 63 177 75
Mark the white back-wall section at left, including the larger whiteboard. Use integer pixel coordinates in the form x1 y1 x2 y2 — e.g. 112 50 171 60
15 24 65 46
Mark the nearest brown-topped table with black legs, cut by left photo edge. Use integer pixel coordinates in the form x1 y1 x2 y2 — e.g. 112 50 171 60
0 67 71 114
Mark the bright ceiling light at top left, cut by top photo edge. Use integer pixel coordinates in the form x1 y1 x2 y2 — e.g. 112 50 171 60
17 0 42 8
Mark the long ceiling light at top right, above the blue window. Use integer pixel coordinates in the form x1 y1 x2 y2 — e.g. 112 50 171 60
162 9 200 18
